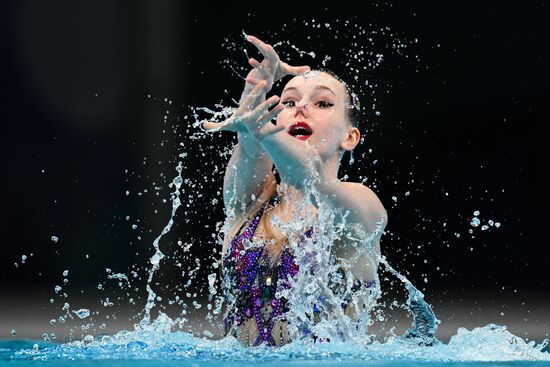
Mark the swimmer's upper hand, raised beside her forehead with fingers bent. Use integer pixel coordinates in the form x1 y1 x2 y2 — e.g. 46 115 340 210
246 35 310 91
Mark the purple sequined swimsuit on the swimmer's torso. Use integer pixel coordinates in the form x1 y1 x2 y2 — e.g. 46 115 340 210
223 197 311 346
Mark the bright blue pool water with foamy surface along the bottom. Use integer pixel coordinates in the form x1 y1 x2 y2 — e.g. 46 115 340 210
0 315 550 366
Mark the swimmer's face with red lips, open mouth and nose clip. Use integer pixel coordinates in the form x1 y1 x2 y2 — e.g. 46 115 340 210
277 71 359 159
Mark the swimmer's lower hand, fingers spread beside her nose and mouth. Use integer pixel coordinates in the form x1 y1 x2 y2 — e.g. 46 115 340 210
202 80 285 140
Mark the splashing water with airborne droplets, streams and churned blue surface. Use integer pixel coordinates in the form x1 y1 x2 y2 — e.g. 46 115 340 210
4 17 550 363
